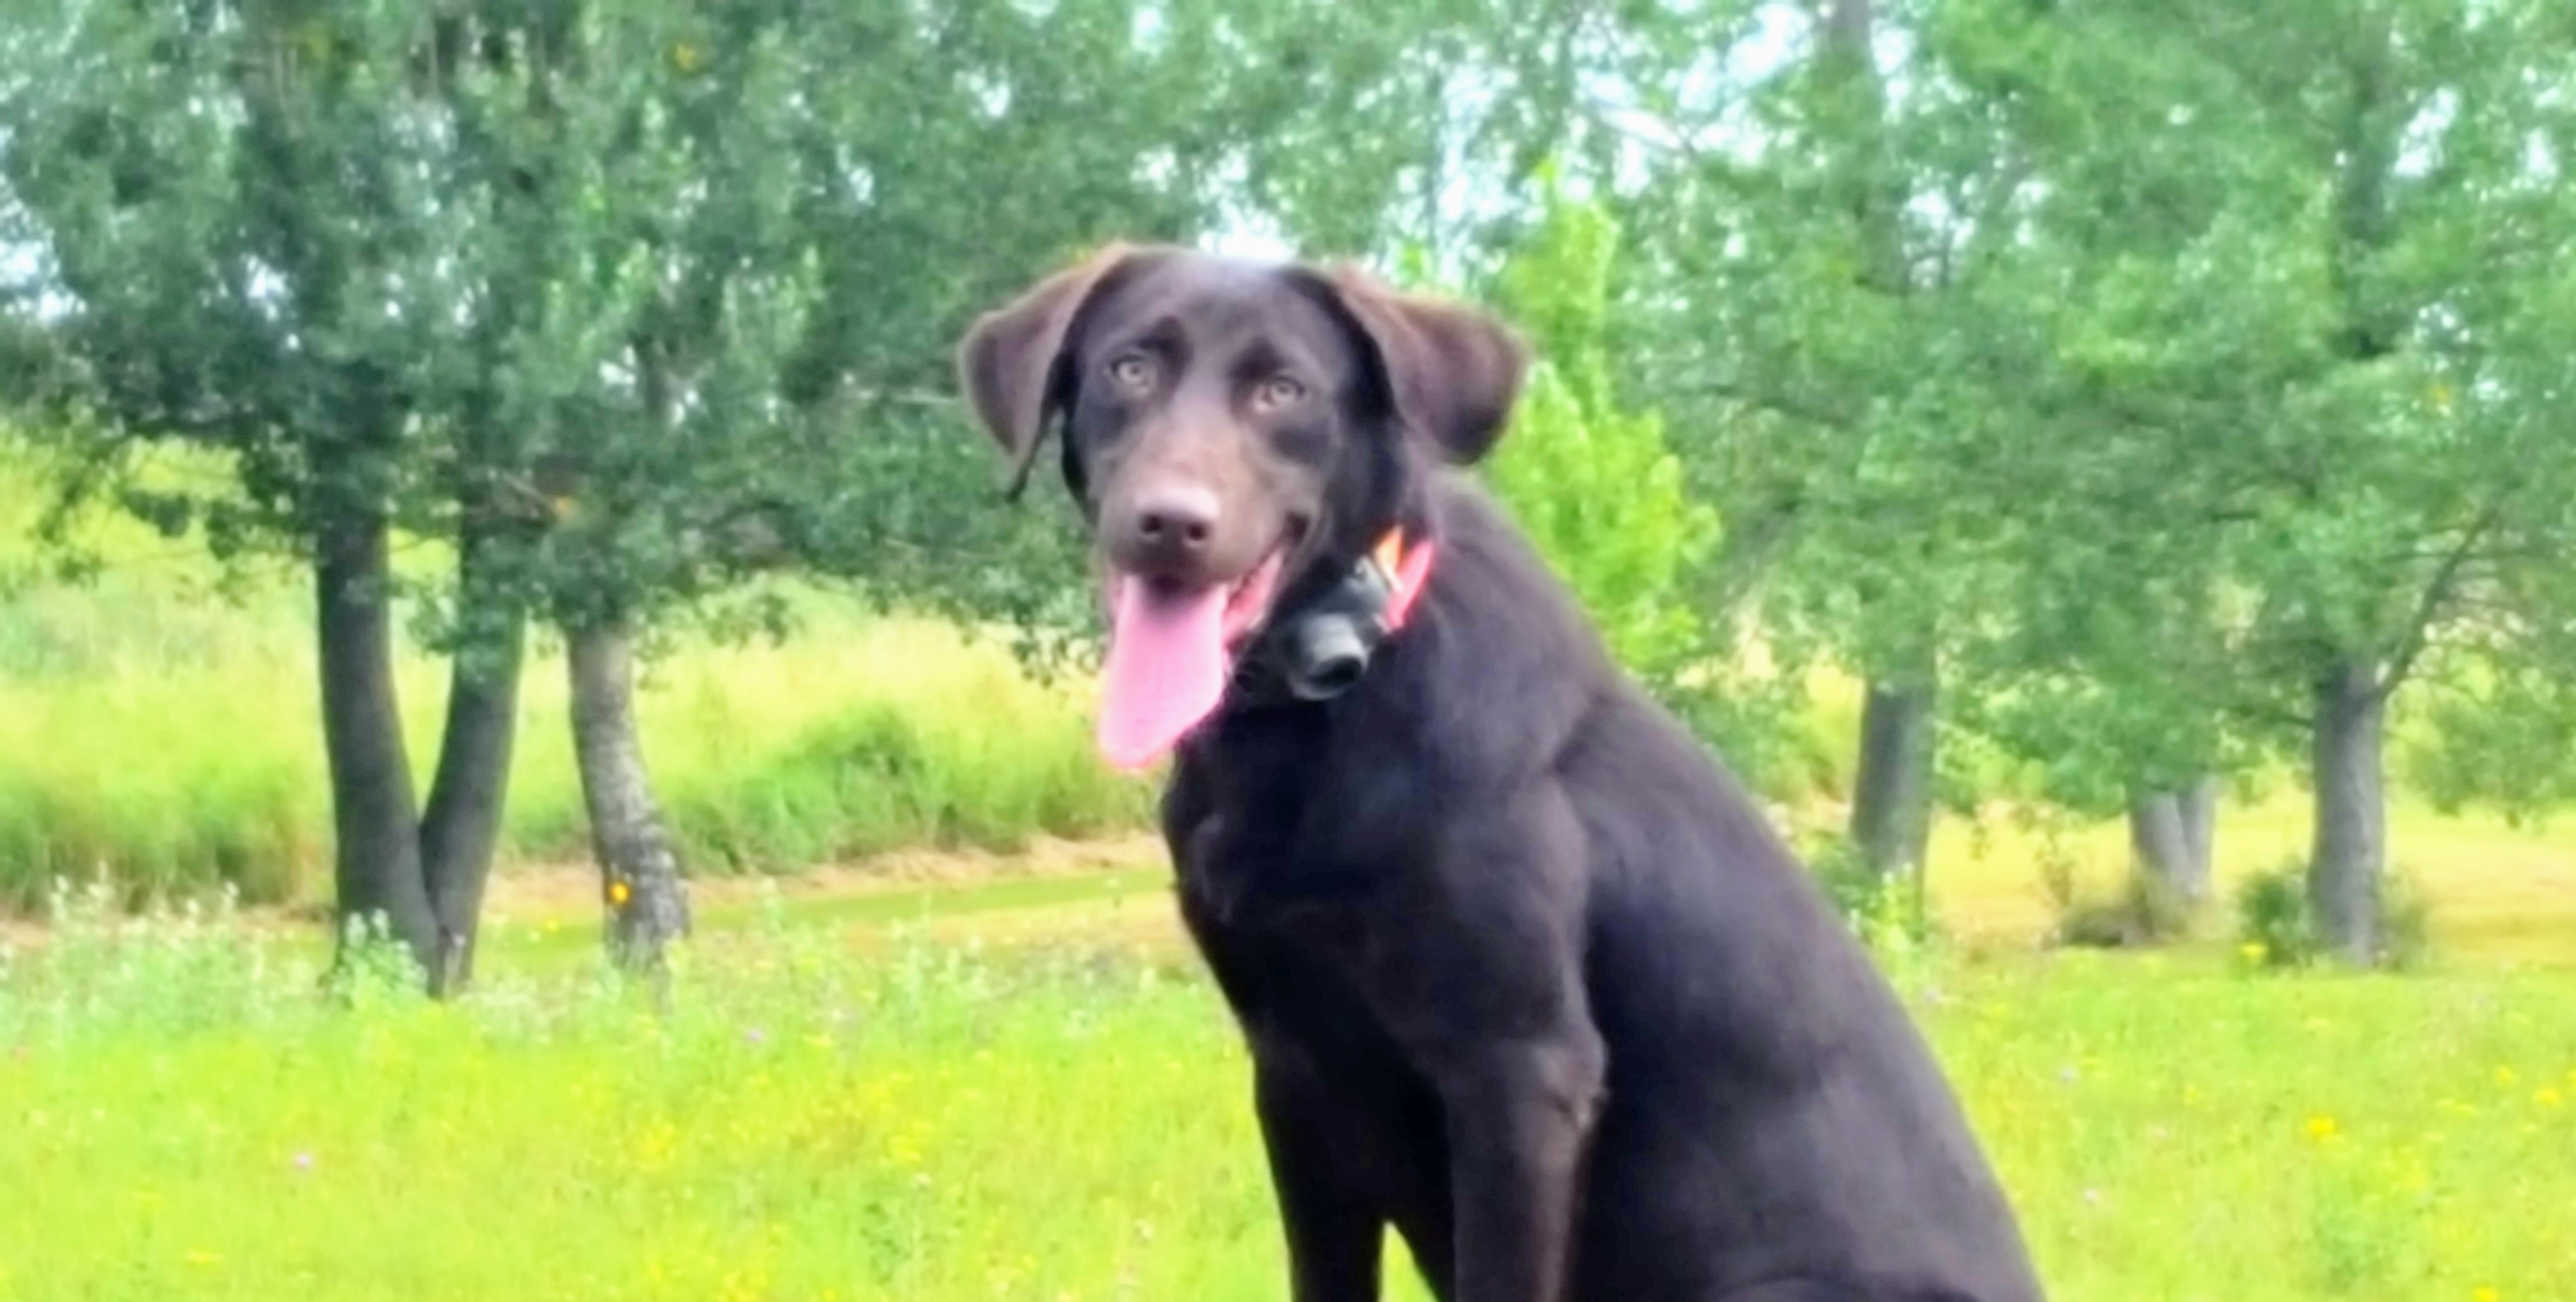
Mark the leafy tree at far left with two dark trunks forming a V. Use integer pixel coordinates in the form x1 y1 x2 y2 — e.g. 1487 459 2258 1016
0 0 538 985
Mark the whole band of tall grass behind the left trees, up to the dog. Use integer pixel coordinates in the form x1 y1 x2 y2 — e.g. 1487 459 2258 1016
0 441 1152 910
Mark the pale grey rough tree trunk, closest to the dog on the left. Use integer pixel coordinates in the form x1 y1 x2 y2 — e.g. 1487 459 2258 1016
564 621 688 969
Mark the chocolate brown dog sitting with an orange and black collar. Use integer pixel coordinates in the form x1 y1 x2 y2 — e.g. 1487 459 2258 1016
961 247 2040 1302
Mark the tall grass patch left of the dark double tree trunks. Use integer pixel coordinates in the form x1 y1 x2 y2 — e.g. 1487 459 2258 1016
0 502 327 912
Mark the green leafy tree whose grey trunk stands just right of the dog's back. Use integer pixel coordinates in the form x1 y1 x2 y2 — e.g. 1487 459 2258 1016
1607 0 2043 892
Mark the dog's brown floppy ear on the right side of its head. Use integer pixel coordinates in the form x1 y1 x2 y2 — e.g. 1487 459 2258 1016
1329 266 1530 464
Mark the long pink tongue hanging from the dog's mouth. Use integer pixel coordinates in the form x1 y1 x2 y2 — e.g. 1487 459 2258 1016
1100 575 1229 771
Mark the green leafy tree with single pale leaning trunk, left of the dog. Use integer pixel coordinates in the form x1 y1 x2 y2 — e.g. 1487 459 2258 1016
495 0 1262 962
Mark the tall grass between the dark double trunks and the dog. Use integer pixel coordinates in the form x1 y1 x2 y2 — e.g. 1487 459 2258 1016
510 611 1152 872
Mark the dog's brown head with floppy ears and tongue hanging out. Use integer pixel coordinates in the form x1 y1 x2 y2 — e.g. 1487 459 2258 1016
959 245 1525 763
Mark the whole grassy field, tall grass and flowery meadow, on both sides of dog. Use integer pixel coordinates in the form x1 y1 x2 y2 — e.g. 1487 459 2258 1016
0 441 2576 1302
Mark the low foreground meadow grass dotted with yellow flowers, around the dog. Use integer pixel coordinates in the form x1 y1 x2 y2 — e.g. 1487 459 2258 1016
0 879 2576 1302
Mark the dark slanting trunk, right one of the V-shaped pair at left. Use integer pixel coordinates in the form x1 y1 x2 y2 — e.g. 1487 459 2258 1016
420 529 528 995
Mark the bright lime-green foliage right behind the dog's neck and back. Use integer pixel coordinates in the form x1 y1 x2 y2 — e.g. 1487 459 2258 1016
1487 193 1718 686
